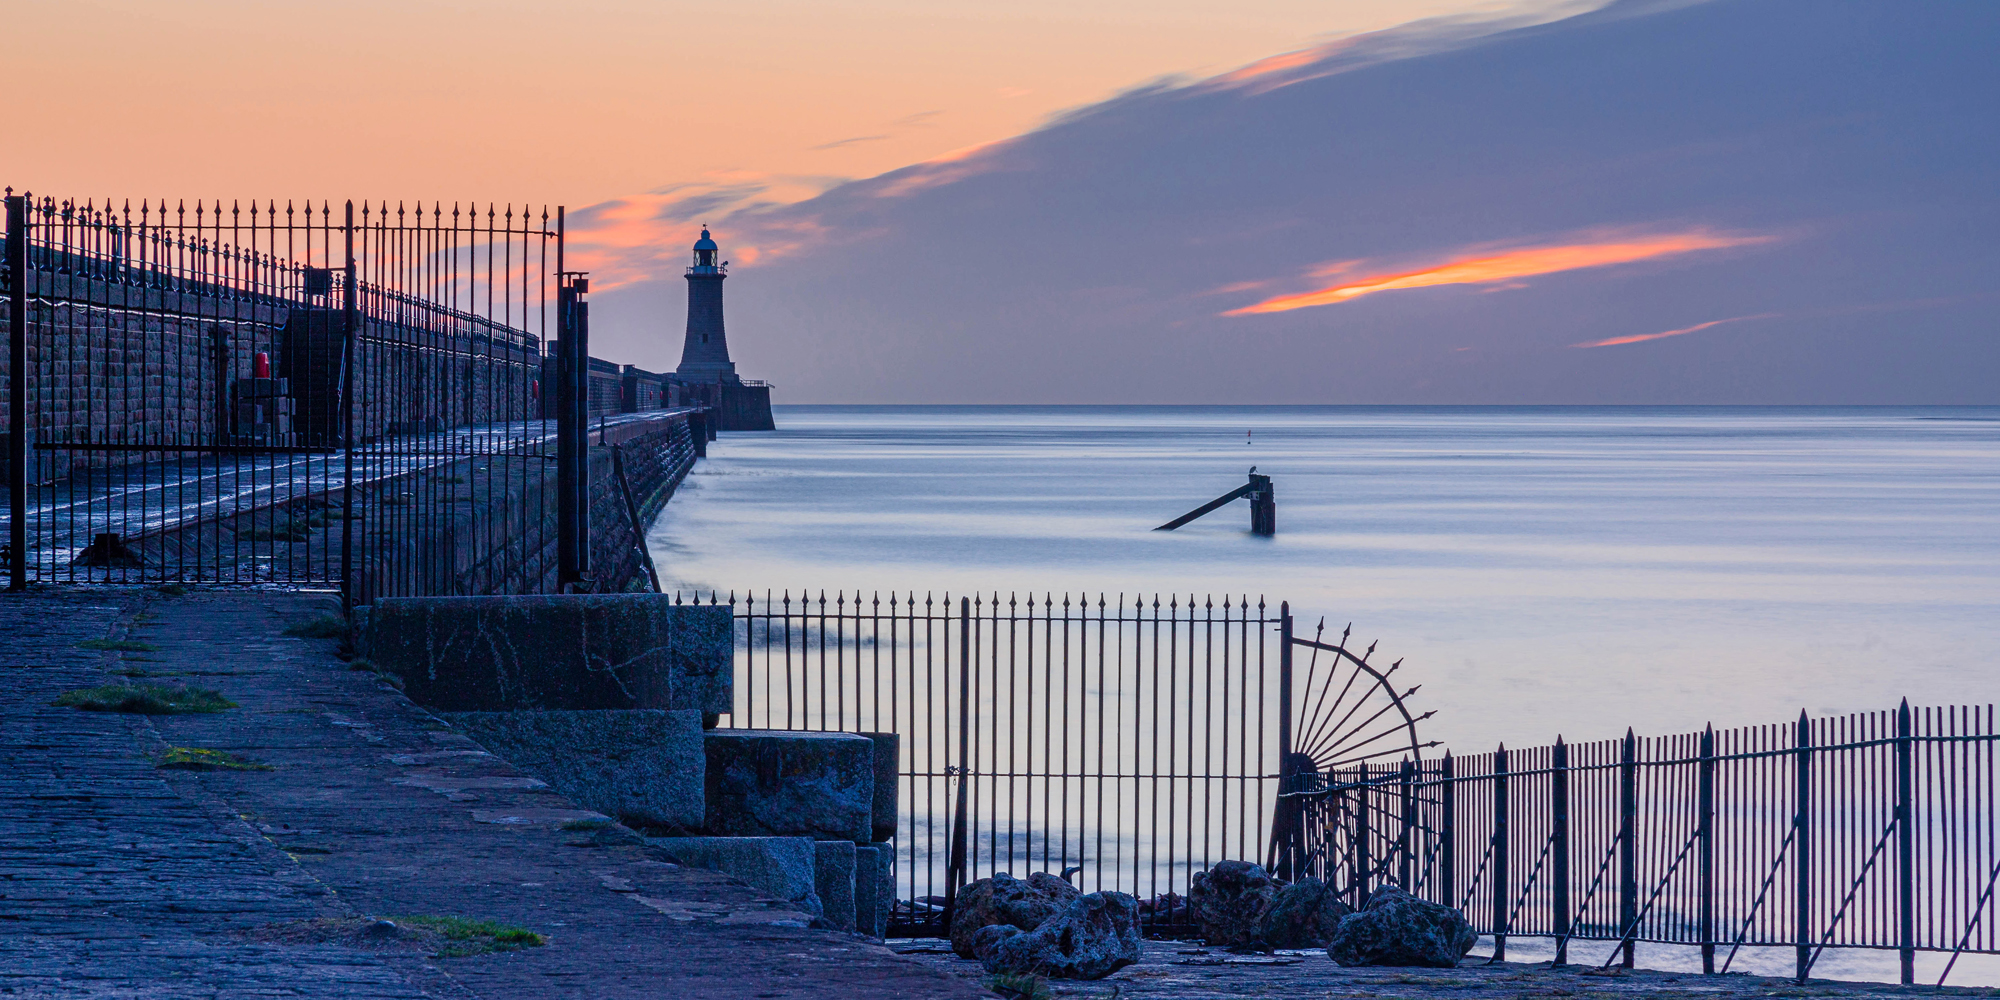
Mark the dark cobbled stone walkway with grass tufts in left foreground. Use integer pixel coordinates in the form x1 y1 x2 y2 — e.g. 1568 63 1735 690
0 588 990 1000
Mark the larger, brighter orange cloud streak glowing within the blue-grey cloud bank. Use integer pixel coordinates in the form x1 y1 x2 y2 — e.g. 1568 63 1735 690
1224 230 1772 316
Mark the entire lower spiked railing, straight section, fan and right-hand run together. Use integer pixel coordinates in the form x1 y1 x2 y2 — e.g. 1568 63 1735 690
682 594 2000 974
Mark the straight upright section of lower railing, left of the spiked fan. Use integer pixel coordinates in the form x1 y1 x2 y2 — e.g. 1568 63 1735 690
684 594 1280 936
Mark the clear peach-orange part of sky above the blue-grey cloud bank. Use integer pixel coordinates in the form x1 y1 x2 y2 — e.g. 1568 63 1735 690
0 0 1568 210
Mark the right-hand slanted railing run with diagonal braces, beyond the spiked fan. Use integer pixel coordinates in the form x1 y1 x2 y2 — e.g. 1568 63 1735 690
1282 704 2000 982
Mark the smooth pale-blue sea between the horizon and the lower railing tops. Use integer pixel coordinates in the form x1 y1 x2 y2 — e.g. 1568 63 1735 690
648 406 2000 982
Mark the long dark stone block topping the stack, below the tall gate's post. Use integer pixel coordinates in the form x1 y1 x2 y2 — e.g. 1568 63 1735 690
364 594 734 714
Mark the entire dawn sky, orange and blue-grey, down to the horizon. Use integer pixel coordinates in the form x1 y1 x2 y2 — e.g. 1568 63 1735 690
0 0 2000 404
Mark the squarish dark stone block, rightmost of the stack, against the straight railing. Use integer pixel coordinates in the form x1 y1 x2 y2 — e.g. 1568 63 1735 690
702 730 876 844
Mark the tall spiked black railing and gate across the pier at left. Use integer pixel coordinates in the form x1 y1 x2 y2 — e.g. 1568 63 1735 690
4 190 692 602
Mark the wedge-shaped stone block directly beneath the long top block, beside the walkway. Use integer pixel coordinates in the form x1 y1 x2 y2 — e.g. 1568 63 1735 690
444 708 704 830
